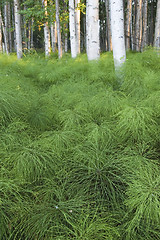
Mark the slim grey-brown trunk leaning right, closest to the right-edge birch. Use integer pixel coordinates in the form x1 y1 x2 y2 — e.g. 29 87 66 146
141 0 148 50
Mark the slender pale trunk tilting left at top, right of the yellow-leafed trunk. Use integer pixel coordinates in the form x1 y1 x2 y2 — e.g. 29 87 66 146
56 0 62 58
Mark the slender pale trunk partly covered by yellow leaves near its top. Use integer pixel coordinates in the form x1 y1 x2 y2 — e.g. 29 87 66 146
42 0 51 57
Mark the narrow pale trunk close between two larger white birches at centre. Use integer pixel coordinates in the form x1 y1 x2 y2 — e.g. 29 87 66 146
75 0 81 54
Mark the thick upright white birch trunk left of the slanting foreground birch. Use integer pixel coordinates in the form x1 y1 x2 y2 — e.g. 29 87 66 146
86 0 100 61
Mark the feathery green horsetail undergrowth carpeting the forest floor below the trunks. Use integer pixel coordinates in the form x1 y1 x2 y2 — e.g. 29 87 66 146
0 50 160 240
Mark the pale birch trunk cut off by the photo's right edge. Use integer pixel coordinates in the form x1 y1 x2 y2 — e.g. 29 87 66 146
154 0 160 48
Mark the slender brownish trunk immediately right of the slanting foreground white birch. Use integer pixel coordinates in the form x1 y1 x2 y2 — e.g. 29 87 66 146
125 0 132 49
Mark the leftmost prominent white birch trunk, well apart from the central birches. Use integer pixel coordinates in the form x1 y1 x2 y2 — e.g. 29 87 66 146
14 0 22 59
